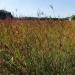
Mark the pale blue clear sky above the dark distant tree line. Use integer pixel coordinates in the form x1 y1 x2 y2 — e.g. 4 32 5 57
0 0 75 17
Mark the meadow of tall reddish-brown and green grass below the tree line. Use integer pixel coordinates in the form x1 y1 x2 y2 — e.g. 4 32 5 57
0 20 75 75
